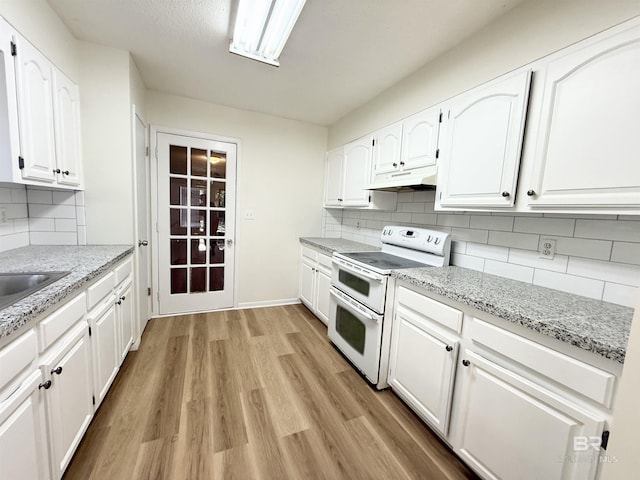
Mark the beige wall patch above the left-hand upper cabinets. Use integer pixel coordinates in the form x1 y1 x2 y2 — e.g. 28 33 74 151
0 0 79 83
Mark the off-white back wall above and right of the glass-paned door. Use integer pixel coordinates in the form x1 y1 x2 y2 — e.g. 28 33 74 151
147 91 327 306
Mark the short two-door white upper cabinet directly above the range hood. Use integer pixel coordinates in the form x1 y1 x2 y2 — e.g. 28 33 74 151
370 107 440 188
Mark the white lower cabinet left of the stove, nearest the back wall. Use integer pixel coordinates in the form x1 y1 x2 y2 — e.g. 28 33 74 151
299 246 331 325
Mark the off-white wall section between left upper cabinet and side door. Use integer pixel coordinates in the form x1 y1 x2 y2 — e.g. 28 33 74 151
79 42 133 244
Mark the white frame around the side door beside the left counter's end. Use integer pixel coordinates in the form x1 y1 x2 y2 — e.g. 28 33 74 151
131 104 153 350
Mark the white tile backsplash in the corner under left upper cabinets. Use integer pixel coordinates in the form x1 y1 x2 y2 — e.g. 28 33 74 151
0 184 87 251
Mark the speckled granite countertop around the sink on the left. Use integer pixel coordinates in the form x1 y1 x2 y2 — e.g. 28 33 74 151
0 245 133 346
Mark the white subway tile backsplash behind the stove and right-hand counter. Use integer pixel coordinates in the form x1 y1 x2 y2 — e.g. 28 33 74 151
322 192 640 307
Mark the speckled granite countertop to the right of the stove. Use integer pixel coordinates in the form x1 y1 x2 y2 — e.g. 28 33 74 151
392 266 633 363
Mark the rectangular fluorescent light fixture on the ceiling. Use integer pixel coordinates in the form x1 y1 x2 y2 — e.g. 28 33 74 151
229 0 306 67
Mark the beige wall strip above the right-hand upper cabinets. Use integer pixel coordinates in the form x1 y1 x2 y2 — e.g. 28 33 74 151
329 0 640 148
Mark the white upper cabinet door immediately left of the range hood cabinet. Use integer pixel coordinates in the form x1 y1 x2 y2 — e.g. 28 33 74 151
342 137 373 207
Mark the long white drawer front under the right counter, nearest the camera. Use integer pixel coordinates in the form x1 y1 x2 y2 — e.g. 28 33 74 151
471 318 616 408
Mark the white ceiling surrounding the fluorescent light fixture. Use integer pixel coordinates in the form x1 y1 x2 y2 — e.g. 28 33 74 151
48 0 523 125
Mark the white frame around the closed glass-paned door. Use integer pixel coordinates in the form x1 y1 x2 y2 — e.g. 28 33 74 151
150 125 241 317
